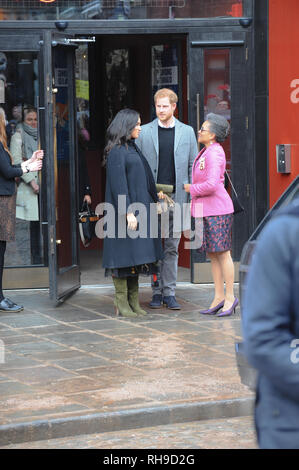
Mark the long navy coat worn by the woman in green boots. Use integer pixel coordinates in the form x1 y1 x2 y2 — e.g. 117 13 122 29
103 143 162 268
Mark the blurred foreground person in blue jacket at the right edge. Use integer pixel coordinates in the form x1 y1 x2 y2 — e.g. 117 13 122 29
242 197 299 449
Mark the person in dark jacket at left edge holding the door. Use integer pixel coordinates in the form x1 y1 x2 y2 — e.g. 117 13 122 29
0 108 44 312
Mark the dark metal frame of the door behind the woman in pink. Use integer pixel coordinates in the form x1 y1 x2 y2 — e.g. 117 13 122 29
188 32 255 283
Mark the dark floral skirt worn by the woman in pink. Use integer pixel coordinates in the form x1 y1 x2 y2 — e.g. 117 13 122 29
198 214 233 253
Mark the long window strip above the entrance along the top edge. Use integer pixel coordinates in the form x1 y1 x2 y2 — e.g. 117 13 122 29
0 0 244 20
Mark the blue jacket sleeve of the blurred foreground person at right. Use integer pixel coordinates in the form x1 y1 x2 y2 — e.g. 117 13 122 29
242 216 299 400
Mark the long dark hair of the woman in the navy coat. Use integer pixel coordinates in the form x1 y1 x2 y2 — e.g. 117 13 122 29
104 108 139 159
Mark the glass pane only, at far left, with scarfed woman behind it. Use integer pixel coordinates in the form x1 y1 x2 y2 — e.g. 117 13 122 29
0 52 43 266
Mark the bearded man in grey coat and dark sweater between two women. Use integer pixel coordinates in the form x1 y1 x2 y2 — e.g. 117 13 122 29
136 88 198 310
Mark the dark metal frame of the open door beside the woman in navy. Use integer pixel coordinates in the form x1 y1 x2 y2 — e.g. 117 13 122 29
43 30 81 305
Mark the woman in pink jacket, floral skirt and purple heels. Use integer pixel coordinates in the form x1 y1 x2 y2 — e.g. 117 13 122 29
184 113 239 317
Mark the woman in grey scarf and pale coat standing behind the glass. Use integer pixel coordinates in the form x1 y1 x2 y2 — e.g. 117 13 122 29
10 106 42 264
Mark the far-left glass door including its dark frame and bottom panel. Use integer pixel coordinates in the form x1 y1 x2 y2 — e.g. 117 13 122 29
0 31 49 289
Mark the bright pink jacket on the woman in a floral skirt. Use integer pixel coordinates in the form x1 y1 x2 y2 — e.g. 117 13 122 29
190 142 234 217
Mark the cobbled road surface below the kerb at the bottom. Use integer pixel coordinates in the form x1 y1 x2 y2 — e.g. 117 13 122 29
2 416 258 449
